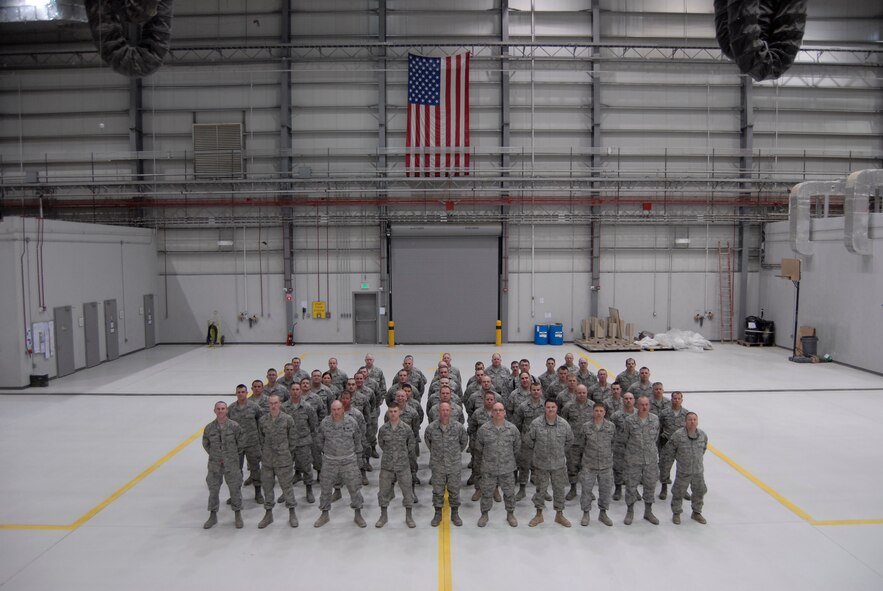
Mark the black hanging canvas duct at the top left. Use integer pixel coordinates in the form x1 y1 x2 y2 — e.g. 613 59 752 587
86 0 173 78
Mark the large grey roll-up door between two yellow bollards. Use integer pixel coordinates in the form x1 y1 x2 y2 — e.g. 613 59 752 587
390 231 499 344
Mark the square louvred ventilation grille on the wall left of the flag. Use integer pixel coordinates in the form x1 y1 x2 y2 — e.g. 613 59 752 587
193 123 242 178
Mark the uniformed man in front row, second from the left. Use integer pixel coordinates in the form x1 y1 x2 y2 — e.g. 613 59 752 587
258 394 298 529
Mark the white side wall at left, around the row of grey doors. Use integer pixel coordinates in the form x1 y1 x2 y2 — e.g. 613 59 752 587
0 217 157 387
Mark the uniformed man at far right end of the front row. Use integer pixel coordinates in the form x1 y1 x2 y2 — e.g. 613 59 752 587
664 412 708 525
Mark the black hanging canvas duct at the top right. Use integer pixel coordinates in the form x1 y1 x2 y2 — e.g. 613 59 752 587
714 0 806 82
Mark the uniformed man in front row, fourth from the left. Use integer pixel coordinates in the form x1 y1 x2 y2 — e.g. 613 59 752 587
374 406 417 527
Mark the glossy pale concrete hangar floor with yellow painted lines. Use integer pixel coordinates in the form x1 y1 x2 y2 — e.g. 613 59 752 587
0 344 883 591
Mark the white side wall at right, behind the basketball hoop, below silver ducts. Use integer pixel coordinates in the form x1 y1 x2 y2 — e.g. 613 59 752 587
760 214 883 372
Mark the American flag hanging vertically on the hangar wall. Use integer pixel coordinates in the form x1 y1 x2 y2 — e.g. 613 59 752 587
405 52 469 176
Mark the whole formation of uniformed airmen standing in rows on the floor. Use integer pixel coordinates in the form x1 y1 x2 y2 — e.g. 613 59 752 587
202 353 708 529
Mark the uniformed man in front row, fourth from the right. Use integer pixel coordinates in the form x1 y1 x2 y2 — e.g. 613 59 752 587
524 400 573 527
